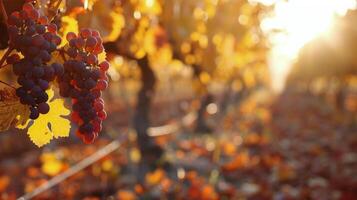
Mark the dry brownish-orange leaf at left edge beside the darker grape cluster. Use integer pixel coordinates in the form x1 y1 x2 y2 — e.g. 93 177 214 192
0 88 30 132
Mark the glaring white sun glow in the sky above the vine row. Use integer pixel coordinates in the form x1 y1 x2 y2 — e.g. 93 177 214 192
256 0 356 90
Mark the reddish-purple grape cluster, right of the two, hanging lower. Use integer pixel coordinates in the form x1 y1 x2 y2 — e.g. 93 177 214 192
57 29 109 143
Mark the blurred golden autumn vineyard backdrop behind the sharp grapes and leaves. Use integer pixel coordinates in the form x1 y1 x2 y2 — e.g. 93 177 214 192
0 0 357 200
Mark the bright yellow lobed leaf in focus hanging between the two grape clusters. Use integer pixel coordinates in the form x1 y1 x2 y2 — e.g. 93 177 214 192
27 89 71 147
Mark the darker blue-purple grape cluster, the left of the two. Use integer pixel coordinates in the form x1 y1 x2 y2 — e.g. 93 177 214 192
7 3 64 119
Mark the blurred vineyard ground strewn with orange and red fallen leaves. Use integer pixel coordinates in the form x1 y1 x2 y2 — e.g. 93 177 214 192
0 92 357 200
